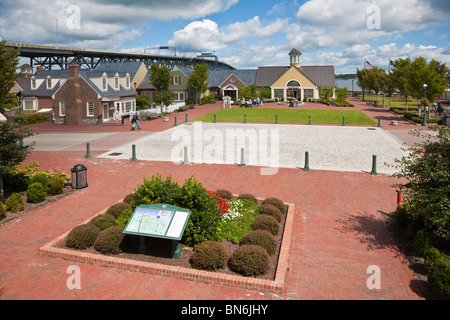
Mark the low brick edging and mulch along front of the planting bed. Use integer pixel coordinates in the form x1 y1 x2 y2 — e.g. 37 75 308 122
39 196 295 294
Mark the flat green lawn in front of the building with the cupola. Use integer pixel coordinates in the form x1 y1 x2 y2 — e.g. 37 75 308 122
193 108 376 125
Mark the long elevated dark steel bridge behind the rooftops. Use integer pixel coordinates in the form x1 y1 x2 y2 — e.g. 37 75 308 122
5 42 235 70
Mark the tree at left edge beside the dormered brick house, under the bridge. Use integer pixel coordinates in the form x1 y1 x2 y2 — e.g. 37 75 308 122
0 41 23 113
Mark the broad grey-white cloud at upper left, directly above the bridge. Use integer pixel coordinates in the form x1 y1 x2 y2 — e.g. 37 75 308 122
0 0 239 49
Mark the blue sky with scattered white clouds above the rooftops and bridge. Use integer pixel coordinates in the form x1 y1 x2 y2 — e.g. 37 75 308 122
0 0 450 74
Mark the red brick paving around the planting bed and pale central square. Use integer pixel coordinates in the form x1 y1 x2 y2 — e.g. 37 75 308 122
0 99 424 300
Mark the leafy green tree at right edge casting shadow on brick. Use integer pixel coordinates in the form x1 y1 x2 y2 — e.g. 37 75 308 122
393 126 450 240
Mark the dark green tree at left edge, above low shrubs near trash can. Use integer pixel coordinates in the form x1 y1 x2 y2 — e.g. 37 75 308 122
0 121 34 199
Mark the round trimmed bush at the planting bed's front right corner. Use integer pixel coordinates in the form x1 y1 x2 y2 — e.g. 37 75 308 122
229 244 269 276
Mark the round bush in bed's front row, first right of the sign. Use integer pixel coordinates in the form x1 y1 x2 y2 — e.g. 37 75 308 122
190 241 228 271
